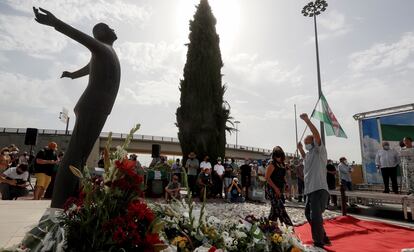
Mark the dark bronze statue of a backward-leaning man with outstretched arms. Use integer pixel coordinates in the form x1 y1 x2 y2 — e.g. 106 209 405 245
33 7 121 208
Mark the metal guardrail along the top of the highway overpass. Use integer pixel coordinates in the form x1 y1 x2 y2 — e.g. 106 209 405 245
0 128 293 156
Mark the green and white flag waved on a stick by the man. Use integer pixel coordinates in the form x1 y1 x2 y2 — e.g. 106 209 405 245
312 94 347 138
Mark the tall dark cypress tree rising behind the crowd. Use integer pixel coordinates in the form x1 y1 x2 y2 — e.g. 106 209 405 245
176 0 231 162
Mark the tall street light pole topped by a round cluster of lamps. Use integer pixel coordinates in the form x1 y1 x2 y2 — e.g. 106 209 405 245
302 0 328 145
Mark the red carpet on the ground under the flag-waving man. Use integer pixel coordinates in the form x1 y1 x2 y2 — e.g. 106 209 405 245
295 216 414 252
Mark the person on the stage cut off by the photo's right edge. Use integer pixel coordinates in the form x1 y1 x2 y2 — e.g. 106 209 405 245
400 137 414 196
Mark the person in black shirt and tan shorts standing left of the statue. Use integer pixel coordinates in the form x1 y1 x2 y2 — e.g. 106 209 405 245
33 142 58 200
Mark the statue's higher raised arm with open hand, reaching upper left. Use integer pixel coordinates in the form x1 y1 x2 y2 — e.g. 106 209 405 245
33 7 102 51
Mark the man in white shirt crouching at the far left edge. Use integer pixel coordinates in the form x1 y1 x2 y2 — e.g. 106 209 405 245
0 164 29 200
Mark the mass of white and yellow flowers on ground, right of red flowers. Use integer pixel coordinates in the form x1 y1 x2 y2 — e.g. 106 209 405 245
150 171 304 252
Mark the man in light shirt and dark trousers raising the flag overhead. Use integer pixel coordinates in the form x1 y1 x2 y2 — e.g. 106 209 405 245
298 114 331 248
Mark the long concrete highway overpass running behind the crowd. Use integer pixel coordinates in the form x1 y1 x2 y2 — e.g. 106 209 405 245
0 128 291 166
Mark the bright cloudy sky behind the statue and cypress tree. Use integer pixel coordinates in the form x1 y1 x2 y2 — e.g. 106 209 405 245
0 0 414 162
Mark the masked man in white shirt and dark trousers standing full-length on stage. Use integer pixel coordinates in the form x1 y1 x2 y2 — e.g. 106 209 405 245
375 141 400 194
